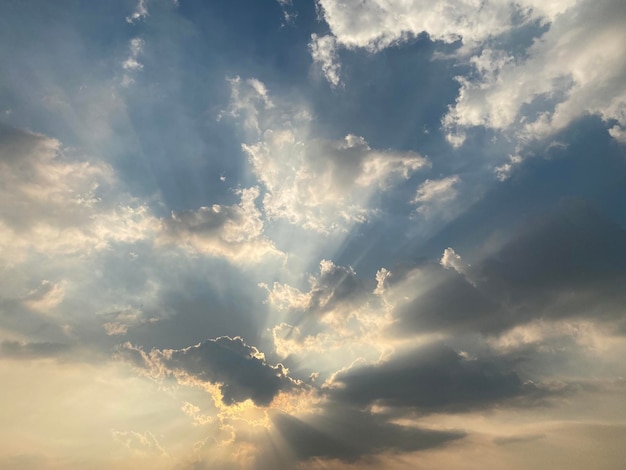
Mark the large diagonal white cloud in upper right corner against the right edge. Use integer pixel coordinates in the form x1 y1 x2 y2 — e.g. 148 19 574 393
443 0 626 143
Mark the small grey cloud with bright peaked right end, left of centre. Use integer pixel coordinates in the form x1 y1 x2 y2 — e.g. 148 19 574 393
161 187 282 263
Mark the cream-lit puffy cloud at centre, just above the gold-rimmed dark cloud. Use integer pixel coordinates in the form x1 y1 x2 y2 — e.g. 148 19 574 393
261 260 391 369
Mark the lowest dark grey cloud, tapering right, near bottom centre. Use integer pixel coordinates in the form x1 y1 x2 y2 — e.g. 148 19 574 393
272 404 464 461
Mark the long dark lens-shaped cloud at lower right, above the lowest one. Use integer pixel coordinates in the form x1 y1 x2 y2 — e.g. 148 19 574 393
328 345 538 412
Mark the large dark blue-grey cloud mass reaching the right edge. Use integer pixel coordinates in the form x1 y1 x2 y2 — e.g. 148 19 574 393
395 203 626 333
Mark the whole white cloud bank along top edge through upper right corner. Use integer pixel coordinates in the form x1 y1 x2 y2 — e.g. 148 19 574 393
312 0 626 146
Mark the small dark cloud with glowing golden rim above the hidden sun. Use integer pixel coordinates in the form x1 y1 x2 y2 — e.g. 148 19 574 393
119 336 297 406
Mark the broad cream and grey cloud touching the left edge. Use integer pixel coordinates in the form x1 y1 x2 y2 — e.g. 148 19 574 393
0 126 155 262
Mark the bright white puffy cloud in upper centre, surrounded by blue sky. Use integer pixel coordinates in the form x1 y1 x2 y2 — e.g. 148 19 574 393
229 80 428 232
